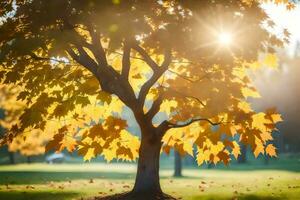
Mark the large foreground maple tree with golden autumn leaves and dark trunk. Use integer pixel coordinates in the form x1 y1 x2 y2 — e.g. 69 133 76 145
0 0 292 198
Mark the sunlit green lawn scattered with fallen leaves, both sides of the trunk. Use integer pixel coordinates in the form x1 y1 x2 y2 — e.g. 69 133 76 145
0 164 300 200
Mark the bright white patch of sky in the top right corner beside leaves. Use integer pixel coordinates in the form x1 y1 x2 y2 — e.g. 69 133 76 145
263 3 300 53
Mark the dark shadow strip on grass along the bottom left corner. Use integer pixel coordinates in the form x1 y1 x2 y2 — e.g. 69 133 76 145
0 191 80 200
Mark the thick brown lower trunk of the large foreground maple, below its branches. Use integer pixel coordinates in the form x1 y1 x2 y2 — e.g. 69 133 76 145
132 133 162 195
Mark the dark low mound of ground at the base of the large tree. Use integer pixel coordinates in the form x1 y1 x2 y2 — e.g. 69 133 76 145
90 192 176 200
